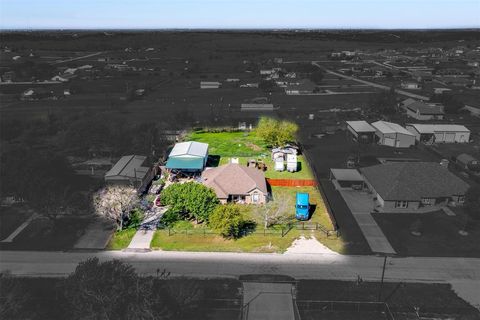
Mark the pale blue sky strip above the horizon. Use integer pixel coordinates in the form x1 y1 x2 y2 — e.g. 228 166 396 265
0 0 480 29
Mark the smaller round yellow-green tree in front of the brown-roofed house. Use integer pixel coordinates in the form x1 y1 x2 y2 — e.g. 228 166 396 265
208 204 248 239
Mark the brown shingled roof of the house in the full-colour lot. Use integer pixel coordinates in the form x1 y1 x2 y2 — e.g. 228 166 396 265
202 163 268 198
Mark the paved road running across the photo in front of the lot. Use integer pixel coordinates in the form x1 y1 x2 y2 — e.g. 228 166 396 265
0 251 480 282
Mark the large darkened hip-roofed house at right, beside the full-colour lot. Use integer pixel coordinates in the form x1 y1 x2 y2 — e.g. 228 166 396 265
360 162 469 212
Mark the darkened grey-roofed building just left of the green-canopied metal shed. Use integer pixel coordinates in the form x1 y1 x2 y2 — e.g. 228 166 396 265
105 155 155 192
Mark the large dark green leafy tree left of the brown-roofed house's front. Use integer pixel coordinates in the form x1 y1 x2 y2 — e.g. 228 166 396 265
161 182 218 222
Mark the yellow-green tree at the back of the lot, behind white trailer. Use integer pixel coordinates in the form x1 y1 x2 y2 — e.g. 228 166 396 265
255 117 298 146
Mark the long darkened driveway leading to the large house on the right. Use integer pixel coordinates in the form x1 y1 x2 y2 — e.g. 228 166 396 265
339 190 396 254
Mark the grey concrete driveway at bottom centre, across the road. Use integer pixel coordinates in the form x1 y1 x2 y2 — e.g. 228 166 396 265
243 282 295 320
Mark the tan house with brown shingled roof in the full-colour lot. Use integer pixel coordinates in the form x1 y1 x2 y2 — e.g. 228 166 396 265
201 163 268 204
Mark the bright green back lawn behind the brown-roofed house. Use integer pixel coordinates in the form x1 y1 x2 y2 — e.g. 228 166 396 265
185 131 269 157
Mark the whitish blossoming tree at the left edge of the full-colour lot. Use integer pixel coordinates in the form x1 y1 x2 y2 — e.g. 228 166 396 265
93 186 139 230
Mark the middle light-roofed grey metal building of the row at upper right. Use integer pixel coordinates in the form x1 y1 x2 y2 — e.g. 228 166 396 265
372 121 415 148
